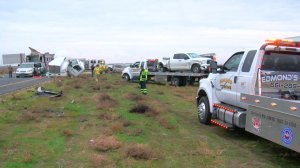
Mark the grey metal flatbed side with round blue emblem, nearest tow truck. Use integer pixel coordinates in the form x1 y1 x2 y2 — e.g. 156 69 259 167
246 96 300 152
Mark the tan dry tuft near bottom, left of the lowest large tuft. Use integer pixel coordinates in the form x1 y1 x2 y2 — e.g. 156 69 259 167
92 136 121 152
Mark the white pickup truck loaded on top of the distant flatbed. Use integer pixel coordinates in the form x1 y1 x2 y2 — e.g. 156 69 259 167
158 53 211 73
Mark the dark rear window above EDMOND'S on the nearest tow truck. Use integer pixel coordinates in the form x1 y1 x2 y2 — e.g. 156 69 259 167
261 51 300 72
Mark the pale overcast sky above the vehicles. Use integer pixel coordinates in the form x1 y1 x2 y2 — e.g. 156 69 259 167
0 0 300 62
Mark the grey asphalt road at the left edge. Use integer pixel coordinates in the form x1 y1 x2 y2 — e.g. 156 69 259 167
0 75 51 95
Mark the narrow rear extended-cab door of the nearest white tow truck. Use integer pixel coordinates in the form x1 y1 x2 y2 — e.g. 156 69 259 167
235 50 257 108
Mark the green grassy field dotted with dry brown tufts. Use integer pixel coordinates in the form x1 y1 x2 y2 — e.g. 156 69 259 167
0 74 300 168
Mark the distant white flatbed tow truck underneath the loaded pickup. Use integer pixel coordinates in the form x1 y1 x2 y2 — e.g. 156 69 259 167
122 59 208 86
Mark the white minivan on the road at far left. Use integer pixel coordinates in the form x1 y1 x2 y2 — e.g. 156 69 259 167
16 62 45 78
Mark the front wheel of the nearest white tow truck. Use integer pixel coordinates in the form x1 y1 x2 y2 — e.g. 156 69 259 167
198 96 211 124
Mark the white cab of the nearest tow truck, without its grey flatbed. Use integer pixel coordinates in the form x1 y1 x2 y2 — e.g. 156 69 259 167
197 39 300 128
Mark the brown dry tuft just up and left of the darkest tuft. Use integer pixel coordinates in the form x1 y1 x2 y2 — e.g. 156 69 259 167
95 93 117 109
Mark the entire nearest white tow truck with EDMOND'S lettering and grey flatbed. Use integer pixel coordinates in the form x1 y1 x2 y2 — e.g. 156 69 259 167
196 39 300 152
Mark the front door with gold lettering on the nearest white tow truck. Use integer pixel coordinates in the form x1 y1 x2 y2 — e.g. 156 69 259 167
215 52 244 105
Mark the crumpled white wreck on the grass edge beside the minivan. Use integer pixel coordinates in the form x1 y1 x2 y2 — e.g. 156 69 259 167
48 57 85 76
